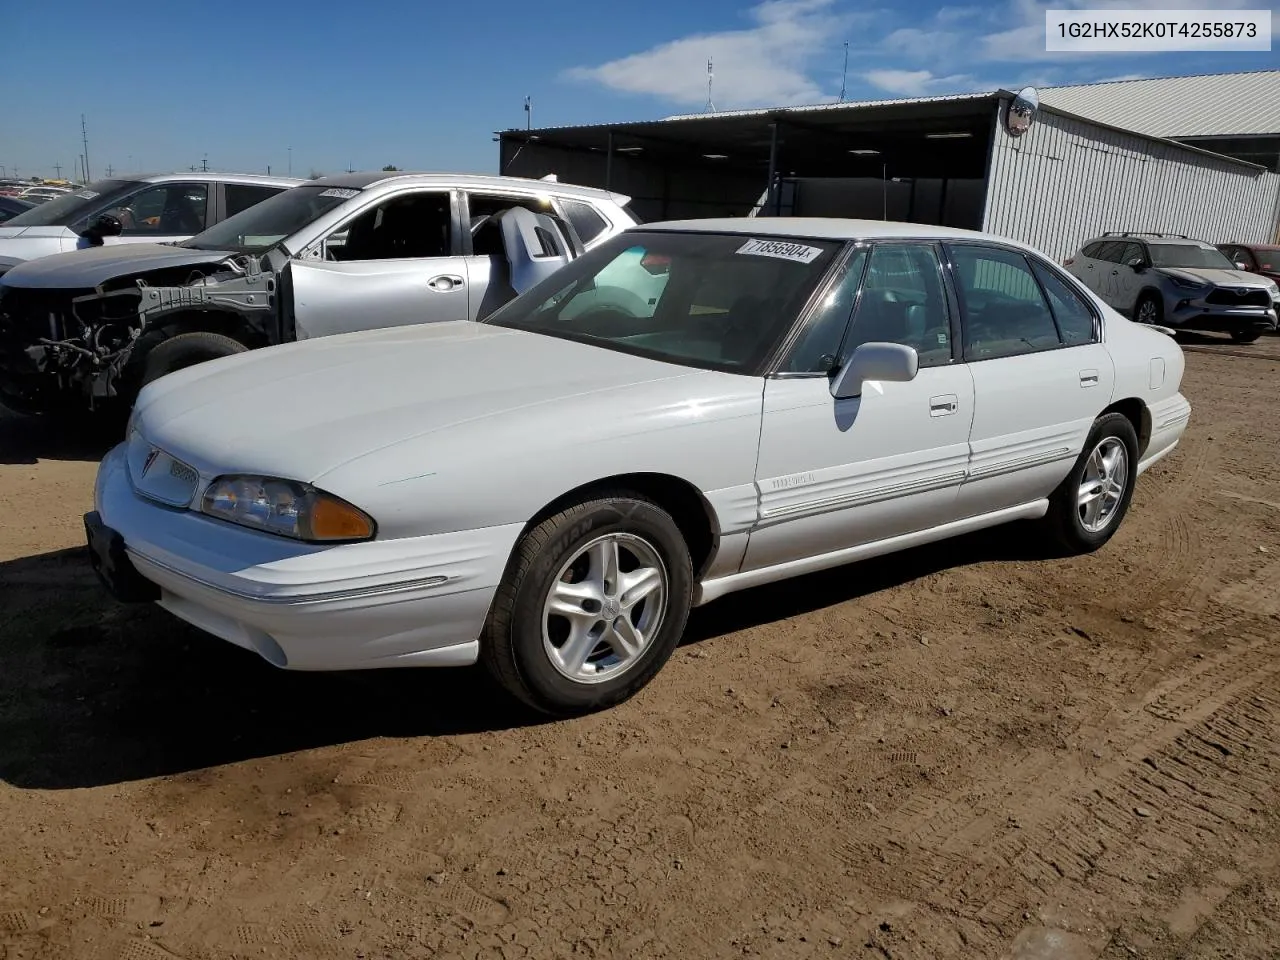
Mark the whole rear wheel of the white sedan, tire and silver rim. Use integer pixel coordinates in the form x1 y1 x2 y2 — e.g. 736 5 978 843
1046 413 1138 553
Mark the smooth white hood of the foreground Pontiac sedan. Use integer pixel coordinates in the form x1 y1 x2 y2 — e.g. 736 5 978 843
134 321 727 481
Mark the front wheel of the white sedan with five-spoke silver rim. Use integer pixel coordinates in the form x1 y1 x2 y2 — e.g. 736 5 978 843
480 492 694 716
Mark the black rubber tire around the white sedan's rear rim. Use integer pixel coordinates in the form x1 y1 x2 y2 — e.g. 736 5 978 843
1044 413 1138 553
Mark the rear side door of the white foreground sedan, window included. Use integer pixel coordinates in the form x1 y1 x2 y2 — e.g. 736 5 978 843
947 242 1115 517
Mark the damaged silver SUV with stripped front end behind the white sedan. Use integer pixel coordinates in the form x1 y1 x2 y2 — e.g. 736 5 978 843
0 173 636 413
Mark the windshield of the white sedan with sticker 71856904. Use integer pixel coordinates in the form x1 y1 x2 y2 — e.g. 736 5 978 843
485 230 841 372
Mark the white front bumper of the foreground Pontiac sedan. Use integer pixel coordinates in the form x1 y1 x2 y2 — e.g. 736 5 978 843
86 444 521 671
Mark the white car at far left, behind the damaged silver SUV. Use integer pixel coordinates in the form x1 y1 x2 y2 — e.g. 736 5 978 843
0 173 306 273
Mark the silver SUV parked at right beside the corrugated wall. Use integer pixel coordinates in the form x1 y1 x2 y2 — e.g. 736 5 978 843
1064 230 1280 343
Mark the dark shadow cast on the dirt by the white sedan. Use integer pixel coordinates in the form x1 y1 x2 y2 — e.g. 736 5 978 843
0 526 1046 790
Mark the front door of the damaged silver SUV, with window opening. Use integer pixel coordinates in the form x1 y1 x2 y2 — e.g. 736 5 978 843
289 189 470 339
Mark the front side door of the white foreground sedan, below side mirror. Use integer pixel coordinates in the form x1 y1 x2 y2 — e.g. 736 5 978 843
744 242 973 570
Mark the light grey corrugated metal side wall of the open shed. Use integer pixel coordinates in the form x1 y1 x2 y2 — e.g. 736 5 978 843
983 102 1280 260
